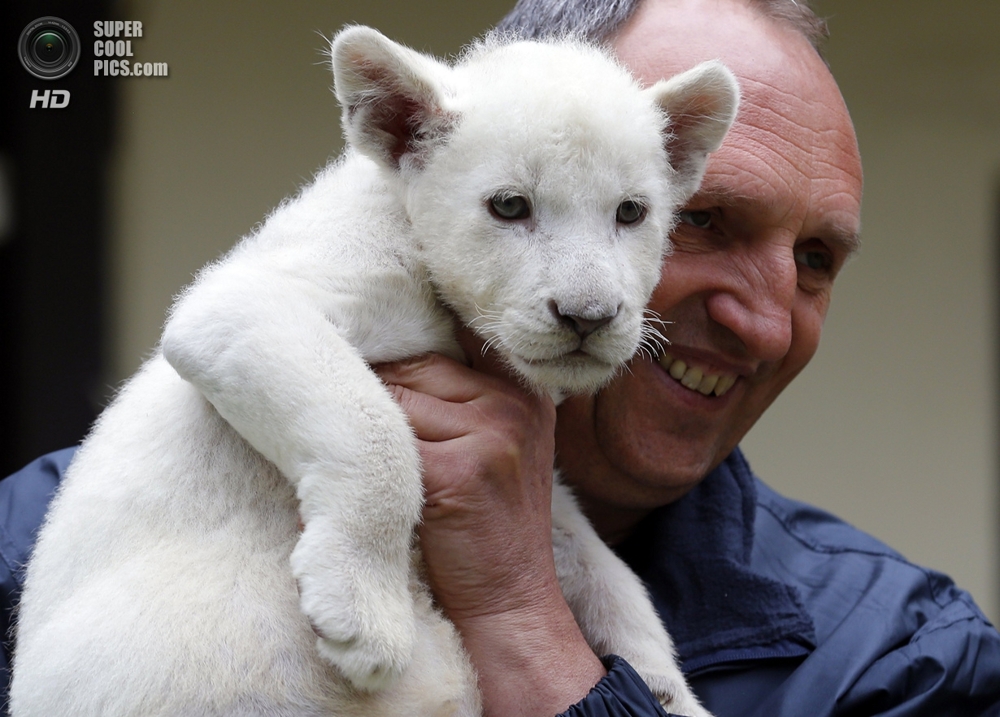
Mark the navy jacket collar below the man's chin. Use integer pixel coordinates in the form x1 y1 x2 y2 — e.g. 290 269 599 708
616 448 816 672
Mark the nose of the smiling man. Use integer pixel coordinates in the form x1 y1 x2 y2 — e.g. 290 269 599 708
706 246 798 361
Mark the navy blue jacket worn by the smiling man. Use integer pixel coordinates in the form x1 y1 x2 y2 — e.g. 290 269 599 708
0 450 1000 717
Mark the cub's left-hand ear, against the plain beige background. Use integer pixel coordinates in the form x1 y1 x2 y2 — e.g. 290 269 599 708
330 25 453 169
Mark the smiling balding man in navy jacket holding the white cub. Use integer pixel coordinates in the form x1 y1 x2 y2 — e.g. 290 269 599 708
0 0 1000 717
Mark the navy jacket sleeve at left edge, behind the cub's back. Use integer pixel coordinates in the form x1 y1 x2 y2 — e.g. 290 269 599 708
0 448 76 702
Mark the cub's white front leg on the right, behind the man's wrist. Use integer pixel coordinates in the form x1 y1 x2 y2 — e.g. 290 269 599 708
552 481 711 717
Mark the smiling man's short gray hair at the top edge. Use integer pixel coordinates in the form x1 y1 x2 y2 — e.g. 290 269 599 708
497 0 829 52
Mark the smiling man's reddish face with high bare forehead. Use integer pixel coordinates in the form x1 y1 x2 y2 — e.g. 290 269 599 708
557 0 861 518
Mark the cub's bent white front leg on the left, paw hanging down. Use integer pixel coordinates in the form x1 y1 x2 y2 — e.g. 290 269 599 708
162 276 423 690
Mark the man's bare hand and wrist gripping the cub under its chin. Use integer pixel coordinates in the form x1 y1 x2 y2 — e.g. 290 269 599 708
376 332 604 717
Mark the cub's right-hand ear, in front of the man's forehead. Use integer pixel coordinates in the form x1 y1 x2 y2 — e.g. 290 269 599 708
646 60 740 203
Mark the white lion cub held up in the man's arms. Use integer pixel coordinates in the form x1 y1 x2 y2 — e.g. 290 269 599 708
12 27 737 717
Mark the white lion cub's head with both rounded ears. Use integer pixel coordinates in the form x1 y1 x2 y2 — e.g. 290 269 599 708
332 27 738 392
